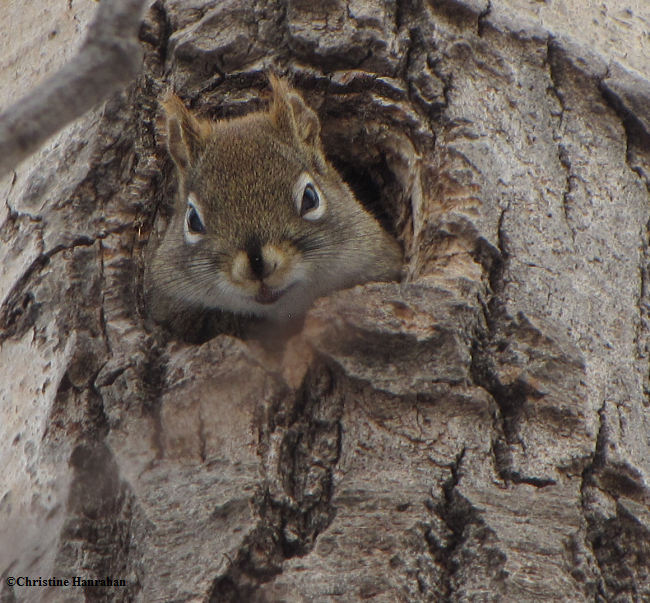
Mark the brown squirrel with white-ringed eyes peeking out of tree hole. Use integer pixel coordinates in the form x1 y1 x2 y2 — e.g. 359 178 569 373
145 75 402 322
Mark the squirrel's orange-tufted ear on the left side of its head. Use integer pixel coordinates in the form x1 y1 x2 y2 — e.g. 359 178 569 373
161 92 210 172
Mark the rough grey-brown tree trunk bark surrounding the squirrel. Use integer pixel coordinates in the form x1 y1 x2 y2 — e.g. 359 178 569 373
0 0 650 602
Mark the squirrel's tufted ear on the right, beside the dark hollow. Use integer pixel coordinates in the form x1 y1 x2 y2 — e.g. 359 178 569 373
269 75 321 151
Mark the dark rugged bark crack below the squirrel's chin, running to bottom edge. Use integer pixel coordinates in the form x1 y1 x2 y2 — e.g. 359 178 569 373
209 366 343 602
